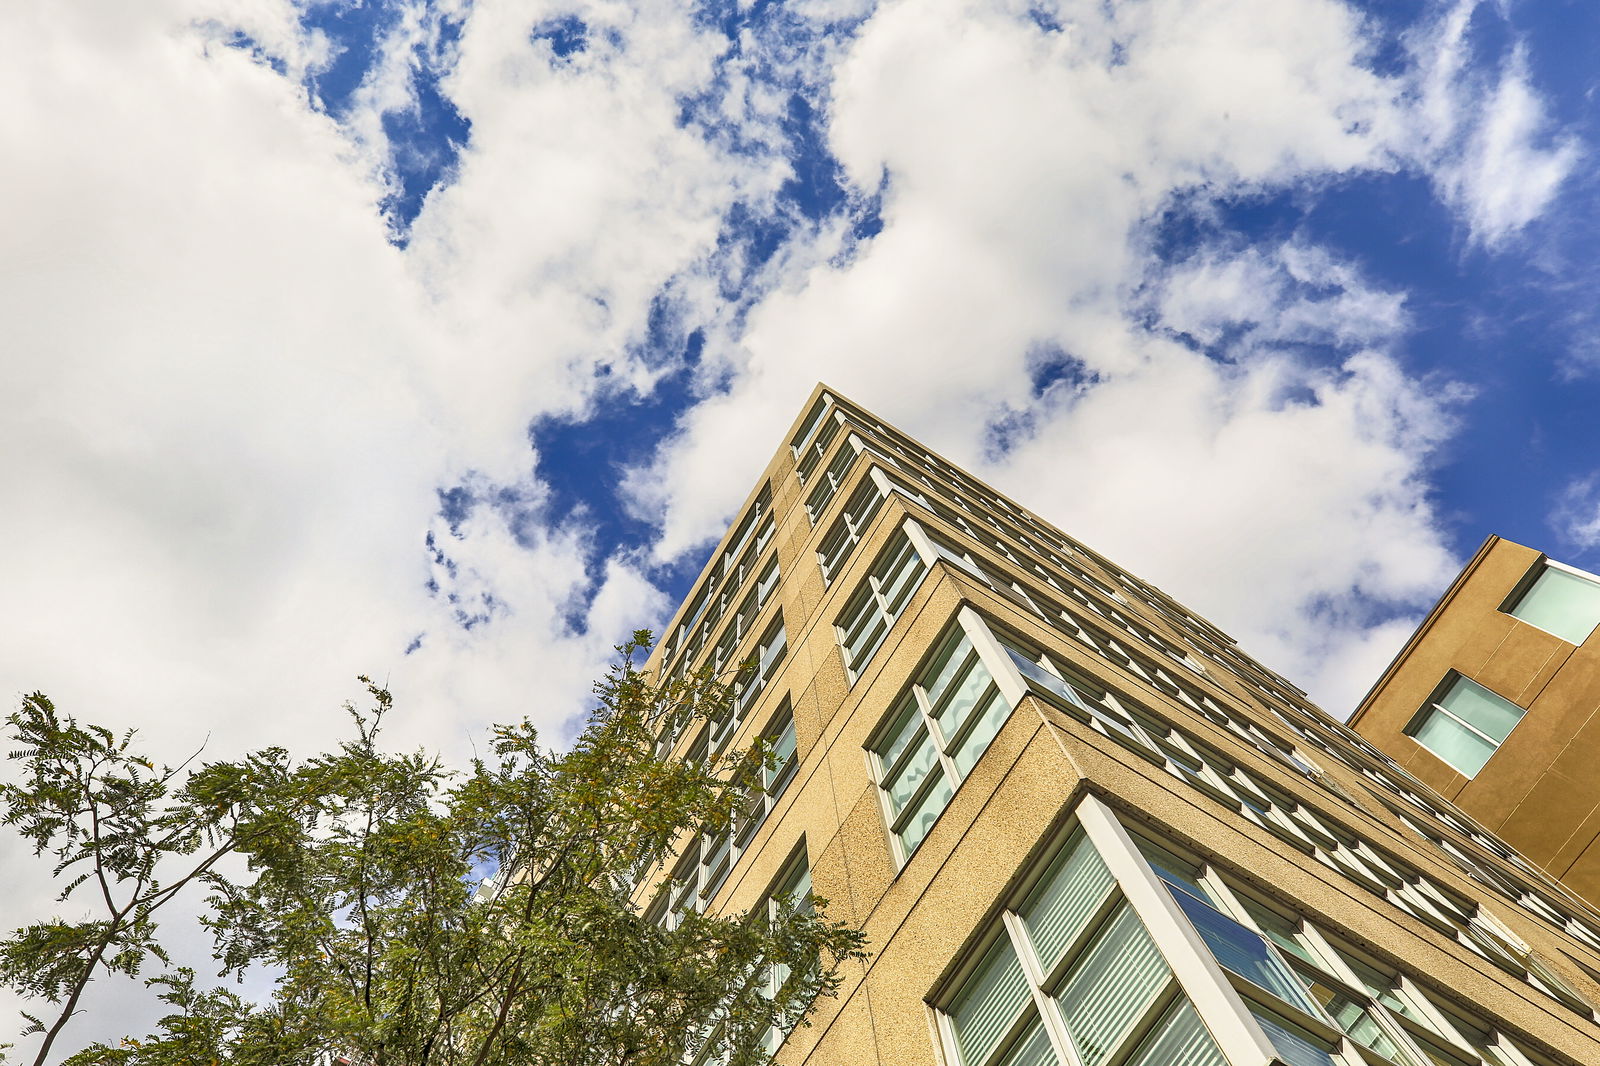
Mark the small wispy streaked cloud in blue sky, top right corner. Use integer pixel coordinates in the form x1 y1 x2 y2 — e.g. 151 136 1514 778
1410 0 1584 248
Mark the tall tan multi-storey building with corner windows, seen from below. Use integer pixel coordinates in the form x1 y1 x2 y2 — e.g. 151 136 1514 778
640 386 1600 1066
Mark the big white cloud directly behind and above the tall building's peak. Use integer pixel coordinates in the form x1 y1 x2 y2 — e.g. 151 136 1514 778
633 0 1461 709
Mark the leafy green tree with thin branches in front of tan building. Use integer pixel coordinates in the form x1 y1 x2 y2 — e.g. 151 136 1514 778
0 632 862 1066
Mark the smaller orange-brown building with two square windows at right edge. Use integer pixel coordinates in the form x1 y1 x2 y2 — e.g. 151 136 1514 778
1350 536 1600 903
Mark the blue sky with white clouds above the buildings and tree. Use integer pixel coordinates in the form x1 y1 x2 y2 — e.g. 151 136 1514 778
0 0 1600 1031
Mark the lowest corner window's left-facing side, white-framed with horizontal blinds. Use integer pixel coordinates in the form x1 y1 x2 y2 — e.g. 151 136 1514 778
939 831 1222 1066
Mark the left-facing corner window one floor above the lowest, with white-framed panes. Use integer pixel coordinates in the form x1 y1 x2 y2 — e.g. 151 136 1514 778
869 623 1011 863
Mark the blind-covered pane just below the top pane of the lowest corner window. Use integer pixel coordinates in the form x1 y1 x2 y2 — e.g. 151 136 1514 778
1058 903 1168 1066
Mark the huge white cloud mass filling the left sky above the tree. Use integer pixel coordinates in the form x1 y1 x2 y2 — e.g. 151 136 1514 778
0 0 748 1039
